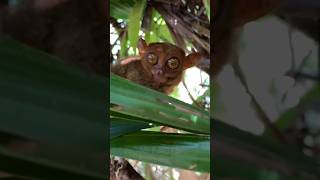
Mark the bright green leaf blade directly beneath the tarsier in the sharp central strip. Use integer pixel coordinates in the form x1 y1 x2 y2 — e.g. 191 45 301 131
110 74 210 134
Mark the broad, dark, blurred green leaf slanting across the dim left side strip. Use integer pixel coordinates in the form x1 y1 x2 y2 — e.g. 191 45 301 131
0 39 108 152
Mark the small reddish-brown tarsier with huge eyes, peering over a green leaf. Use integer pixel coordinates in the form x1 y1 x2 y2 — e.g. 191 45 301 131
111 39 202 94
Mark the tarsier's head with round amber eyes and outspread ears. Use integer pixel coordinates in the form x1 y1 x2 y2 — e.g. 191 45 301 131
138 39 201 86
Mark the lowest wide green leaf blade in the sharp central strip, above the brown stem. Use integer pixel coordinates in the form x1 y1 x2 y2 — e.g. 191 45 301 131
110 132 210 172
